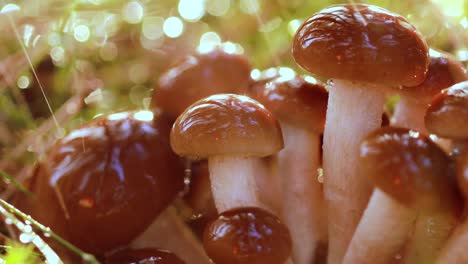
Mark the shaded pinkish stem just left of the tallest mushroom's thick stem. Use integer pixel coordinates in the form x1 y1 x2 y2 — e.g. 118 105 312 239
278 122 327 264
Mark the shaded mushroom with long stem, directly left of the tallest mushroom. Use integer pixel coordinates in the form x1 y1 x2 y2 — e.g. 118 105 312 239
256 74 328 264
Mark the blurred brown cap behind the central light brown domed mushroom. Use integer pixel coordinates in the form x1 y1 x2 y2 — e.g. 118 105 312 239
153 49 251 119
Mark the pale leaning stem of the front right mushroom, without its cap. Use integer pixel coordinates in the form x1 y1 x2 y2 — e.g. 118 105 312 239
343 188 416 264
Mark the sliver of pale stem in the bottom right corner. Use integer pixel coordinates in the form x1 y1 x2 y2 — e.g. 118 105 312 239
435 221 468 264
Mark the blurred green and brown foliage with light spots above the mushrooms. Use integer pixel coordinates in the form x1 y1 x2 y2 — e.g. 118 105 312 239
0 0 468 260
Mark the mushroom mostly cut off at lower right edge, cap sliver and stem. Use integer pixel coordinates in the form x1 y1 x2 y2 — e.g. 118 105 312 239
436 151 468 264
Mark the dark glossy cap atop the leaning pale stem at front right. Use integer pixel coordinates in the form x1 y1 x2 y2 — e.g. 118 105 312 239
360 127 456 207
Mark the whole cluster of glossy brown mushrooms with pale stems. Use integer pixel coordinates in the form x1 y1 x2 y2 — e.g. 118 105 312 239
12 4 468 264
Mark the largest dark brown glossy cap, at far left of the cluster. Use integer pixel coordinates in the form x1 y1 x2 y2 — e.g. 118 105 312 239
32 111 184 254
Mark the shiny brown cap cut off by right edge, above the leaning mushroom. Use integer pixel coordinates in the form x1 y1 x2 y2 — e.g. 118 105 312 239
424 81 468 139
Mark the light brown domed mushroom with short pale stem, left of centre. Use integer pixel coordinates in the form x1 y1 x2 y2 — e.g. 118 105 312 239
171 94 284 212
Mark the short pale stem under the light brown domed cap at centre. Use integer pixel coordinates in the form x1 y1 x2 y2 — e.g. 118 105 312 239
208 155 273 212
